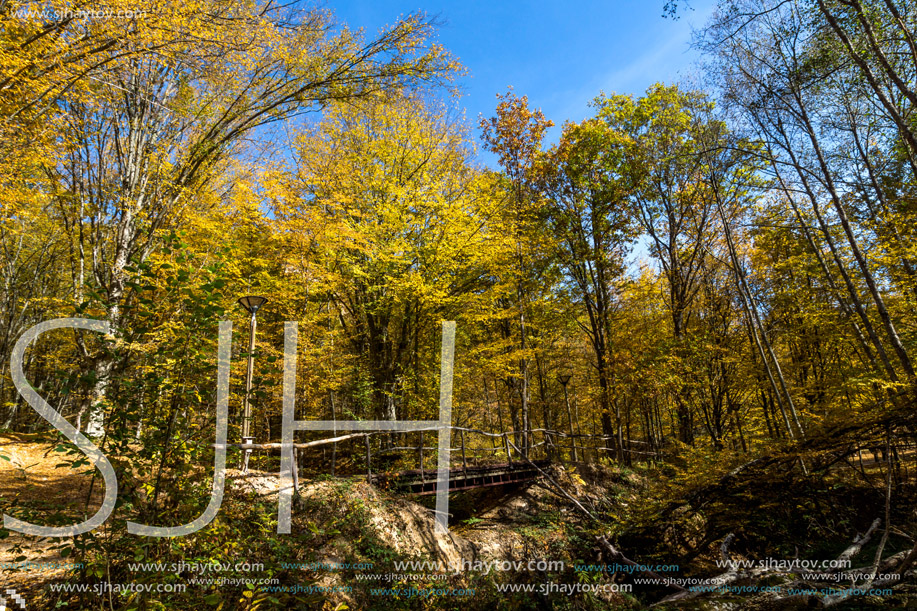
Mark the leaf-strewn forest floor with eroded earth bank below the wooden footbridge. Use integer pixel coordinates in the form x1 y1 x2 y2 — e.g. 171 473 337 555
0 434 915 610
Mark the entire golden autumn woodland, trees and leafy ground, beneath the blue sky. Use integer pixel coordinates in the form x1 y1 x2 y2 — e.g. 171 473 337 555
0 0 917 610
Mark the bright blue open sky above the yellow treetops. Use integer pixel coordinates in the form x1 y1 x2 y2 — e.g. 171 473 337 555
328 0 713 165
